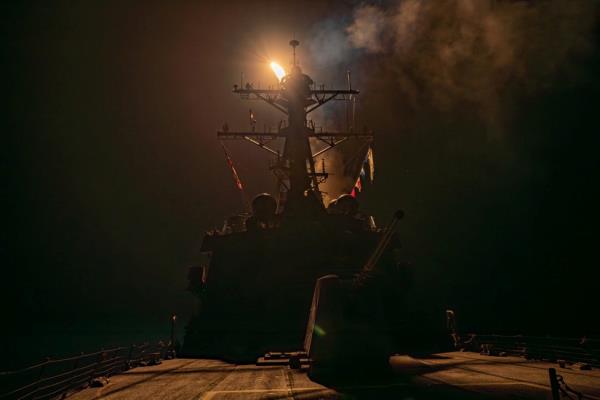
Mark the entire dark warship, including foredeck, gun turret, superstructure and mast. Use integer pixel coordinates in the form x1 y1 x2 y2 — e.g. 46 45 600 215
0 40 600 400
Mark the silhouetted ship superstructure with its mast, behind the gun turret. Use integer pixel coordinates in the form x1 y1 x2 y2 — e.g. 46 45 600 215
184 40 394 361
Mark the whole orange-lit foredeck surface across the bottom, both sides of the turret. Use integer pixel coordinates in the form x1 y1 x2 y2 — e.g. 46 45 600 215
69 352 600 400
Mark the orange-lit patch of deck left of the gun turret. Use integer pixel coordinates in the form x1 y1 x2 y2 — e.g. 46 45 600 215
69 358 335 400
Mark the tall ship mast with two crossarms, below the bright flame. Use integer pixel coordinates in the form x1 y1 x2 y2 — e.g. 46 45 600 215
217 40 373 216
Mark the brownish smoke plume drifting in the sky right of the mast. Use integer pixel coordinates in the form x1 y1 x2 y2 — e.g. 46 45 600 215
346 0 598 126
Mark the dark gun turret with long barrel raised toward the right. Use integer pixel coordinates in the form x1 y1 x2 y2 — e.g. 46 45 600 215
304 210 404 379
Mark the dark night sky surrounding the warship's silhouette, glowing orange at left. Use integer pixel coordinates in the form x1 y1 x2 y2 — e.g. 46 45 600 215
0 0 600 368
